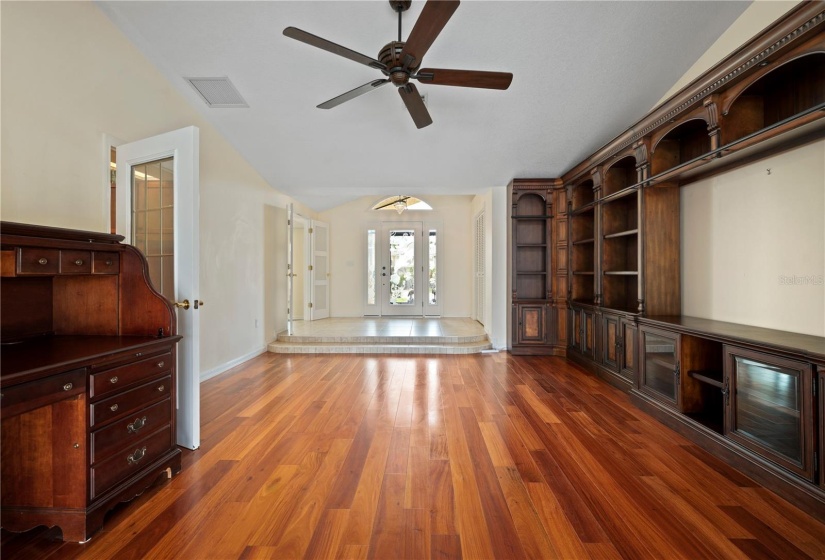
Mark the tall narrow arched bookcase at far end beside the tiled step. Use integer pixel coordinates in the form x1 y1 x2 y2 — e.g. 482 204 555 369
510 179 567 354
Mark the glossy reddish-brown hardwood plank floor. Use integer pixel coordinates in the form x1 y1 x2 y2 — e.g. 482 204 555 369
0 353 825 560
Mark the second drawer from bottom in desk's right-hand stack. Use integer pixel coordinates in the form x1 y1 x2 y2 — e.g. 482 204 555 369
92 399 172 464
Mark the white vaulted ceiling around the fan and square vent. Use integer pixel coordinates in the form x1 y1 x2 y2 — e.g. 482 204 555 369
98 0 749 211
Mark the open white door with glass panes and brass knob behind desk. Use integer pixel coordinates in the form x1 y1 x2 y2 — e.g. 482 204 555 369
116 126 203 449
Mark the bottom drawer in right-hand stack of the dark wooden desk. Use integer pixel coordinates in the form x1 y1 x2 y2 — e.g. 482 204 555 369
89 426 172 499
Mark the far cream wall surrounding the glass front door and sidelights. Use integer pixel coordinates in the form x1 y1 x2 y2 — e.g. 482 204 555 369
319 193 473 317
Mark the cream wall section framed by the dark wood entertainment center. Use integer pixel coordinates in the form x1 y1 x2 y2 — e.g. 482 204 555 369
681 141 825 336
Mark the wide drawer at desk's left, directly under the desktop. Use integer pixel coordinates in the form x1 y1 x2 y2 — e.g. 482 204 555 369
0 369 86 418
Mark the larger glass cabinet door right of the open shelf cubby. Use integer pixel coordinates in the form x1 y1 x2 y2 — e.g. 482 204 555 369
725 347 813 480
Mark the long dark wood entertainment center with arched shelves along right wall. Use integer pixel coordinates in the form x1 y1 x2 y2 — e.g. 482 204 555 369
510 2 825 520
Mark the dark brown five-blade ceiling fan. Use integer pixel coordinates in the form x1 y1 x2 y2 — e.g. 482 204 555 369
284 0 513 128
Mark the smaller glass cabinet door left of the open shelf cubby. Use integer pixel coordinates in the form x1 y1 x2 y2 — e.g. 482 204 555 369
639 329 679 408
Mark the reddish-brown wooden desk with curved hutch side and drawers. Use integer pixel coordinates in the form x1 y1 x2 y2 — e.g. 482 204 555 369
0 223 181 541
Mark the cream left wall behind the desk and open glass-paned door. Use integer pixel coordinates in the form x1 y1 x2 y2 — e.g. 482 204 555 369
0 2 312 375
